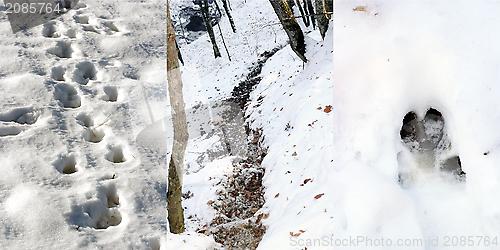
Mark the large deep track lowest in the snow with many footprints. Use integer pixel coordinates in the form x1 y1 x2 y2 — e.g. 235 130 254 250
83 183 122 229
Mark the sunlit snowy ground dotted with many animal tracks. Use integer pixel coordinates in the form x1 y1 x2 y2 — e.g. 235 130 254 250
0 0 166 249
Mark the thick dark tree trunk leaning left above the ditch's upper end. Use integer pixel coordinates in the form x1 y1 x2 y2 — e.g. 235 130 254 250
269 0 307 62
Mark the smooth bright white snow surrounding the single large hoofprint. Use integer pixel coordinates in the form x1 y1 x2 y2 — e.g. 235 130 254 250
333 1 500 249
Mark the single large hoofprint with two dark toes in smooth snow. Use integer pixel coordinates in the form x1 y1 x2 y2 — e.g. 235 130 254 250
400 108 466 181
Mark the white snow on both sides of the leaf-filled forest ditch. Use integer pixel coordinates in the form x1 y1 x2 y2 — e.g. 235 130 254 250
167 0 333 249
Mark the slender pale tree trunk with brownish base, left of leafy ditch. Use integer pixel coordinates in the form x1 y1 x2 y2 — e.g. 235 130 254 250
167 1 189 234
